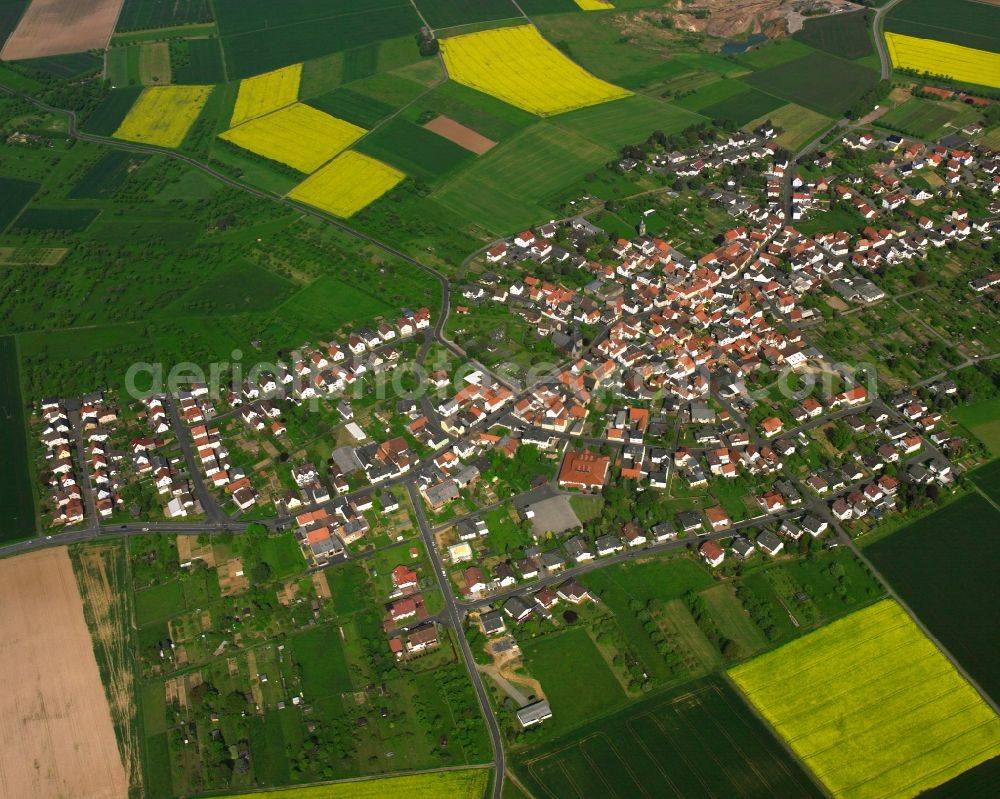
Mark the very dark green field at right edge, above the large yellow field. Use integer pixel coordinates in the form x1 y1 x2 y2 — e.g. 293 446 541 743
865 490 1000 698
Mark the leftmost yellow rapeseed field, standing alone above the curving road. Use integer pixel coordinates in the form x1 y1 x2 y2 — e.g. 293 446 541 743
115 86 213 147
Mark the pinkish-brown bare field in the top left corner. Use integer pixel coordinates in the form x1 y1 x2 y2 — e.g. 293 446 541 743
0 0 123 61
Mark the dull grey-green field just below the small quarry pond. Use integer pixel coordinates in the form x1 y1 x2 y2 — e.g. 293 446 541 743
743 51 878 117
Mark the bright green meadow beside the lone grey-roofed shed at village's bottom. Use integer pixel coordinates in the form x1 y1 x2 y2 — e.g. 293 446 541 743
520 627 626 734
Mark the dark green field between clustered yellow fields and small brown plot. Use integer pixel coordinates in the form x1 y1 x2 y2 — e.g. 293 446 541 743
355 119 475 181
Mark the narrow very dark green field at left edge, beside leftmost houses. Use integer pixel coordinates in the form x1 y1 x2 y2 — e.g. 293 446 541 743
0 336 35 542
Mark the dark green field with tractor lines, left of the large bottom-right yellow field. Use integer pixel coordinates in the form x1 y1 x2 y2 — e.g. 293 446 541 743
511 677 823 799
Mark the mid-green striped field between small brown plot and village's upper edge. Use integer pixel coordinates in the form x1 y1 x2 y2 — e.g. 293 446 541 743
431 122 614 233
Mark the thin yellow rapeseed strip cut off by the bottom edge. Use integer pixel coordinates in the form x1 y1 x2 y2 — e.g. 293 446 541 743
222 768 490 799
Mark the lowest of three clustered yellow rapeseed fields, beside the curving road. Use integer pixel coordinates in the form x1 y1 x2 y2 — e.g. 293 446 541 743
288 150 406 217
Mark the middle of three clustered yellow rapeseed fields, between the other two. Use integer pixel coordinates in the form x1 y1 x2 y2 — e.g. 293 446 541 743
219 103 365 173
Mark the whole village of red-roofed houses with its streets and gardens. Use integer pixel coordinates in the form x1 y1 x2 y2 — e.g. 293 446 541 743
25 84 1000 740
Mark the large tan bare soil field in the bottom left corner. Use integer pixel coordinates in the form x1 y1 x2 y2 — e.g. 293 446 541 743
0 547 128 799
